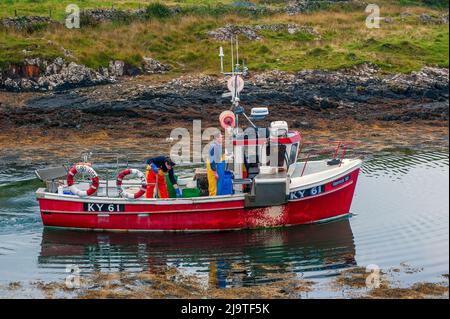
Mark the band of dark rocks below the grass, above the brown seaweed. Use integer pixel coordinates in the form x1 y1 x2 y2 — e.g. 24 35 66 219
0 65 449 129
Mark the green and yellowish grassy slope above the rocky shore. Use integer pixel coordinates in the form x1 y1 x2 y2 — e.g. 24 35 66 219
0 0 449 75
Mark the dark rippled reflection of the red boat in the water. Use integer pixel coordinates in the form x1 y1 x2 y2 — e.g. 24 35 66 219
38 219 356 287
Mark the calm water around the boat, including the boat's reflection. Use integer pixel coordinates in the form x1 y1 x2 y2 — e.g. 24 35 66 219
0 152 449 297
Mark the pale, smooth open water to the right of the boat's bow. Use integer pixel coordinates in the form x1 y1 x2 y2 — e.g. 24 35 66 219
352 153 449 280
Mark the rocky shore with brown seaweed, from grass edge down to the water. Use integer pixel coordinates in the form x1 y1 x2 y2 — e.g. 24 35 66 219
0 65 449 165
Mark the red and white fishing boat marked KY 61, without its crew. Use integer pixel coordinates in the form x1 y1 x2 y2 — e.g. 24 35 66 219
36 39 362 231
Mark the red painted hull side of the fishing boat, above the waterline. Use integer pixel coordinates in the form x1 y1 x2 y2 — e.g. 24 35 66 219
39 169 359 231
